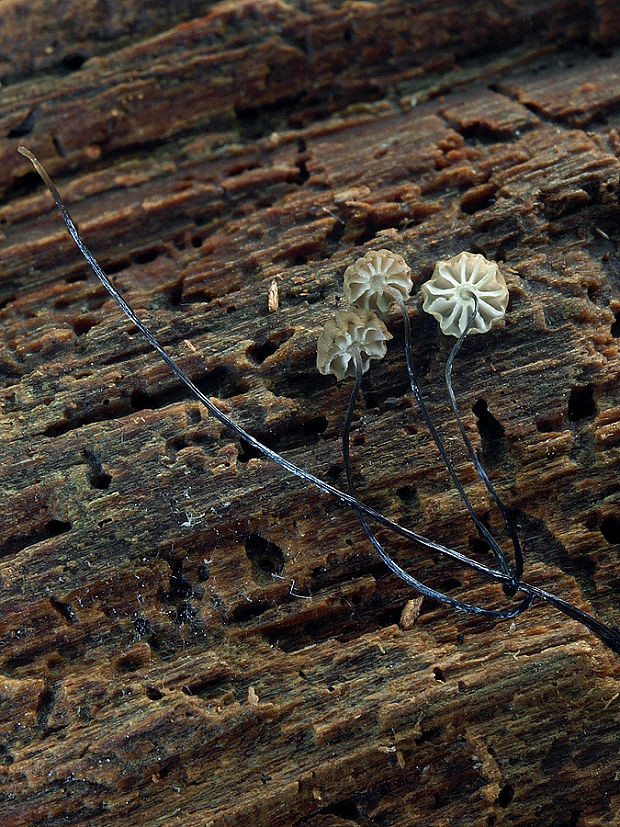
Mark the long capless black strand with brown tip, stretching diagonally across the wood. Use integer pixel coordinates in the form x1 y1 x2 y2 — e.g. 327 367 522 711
18 147 620 653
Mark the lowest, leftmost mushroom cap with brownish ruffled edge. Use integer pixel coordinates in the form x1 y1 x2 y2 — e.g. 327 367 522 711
316 307 392 382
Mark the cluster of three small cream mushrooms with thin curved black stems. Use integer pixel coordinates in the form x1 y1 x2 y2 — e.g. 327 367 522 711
317 250 525 616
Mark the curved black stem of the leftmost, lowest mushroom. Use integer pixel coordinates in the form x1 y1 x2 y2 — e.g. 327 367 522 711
342 360 534 620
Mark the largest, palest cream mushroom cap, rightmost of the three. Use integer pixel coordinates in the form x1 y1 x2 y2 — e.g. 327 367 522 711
421 253 508 338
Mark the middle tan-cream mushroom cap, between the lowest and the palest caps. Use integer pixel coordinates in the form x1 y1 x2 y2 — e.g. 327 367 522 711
343 250 413 313
